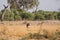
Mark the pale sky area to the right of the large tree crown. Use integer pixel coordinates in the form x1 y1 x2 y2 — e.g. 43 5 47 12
39 0 60 11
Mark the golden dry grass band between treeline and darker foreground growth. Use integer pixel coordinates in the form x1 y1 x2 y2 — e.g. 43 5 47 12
0 21 60 37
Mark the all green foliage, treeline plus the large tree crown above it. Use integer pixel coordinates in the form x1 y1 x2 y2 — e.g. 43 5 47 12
0 0 60 21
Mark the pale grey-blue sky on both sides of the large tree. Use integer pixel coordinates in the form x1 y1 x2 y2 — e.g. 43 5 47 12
0 0 60 11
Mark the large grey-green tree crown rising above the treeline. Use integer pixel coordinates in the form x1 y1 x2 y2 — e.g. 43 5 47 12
8 0 38 9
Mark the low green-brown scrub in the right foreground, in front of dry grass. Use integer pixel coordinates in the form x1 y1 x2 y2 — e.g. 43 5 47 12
21 30 60 40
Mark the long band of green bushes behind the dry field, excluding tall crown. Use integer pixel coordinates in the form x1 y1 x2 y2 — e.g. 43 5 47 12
0 9 60 21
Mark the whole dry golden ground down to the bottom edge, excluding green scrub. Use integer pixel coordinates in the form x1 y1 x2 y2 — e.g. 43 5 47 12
0 20 60 40
